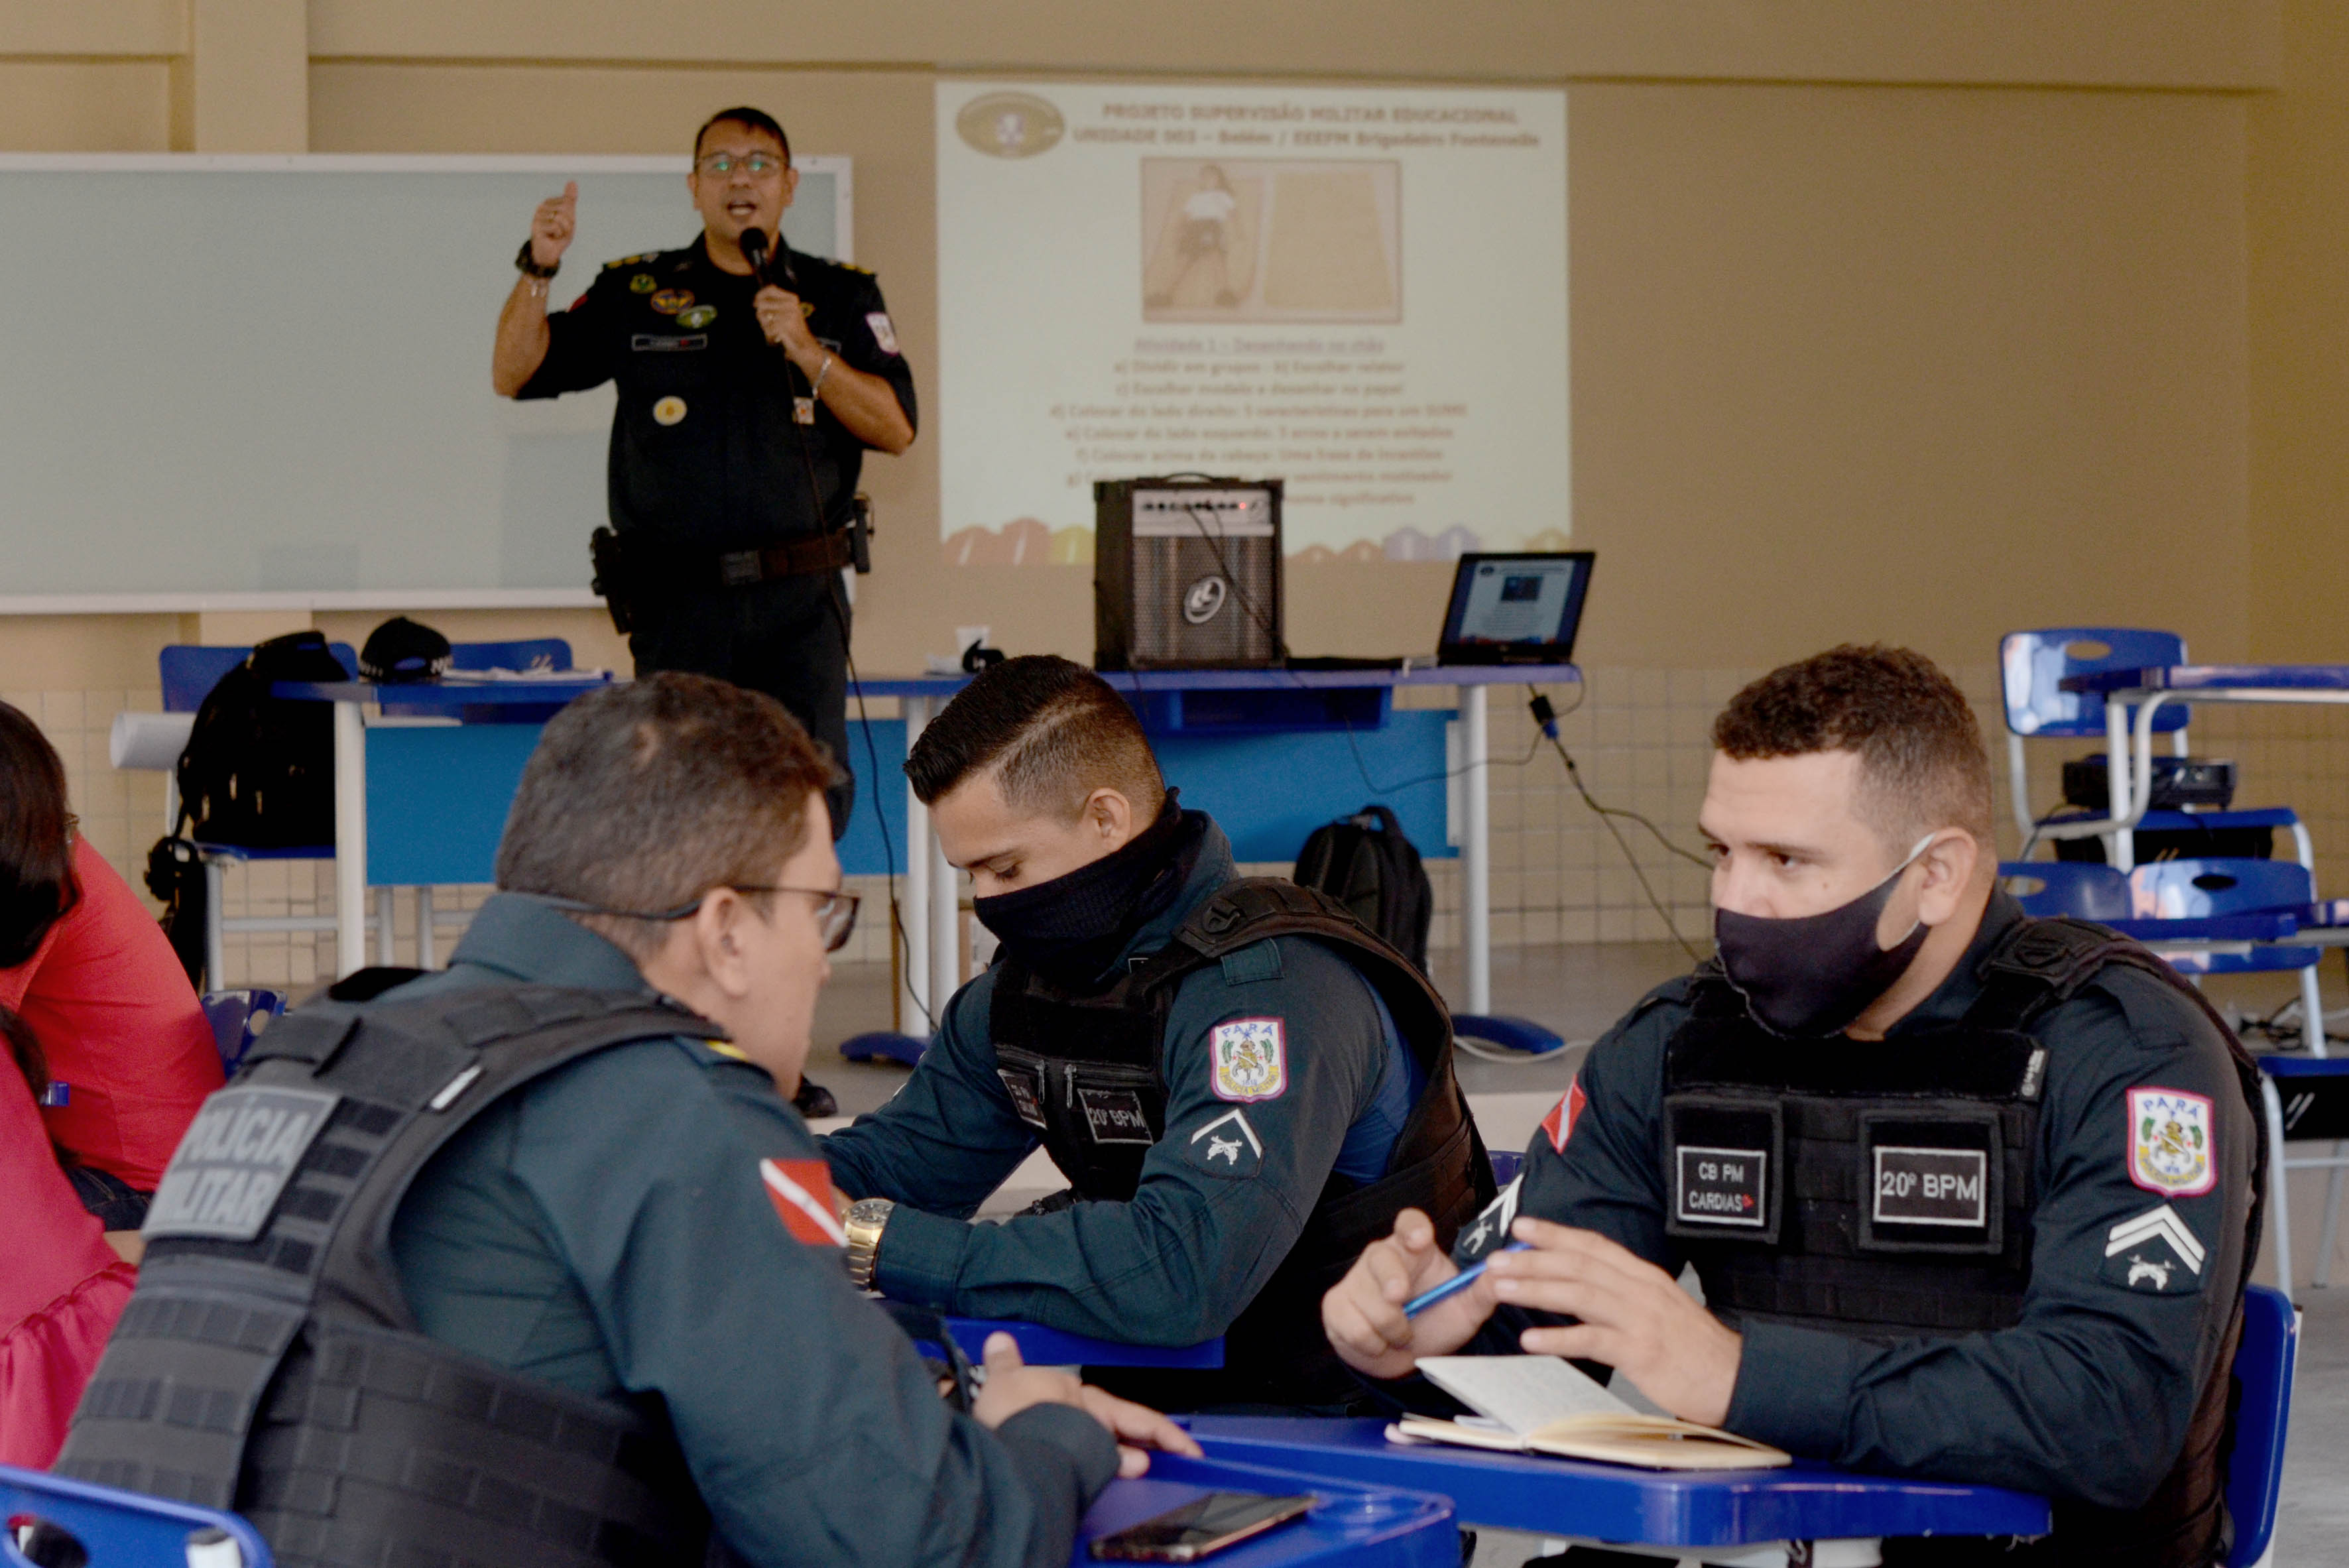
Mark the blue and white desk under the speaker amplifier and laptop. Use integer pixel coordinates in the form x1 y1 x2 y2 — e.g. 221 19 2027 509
862 664 1583 1059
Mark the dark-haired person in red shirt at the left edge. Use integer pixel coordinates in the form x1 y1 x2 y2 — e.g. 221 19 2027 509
0 702 221 1233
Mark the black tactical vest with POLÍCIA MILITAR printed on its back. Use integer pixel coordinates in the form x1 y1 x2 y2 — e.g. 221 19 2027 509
56 986 723 1568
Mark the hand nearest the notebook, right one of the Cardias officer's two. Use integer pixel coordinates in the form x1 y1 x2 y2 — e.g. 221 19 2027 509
1484 1218 1745 1427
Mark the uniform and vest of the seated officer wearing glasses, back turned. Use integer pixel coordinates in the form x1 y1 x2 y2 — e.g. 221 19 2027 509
59 894 1116 1568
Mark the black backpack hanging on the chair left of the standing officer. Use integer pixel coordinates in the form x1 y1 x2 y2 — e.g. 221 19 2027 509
178 631 350 850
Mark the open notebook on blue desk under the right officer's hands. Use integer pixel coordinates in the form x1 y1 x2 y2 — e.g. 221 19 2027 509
1386 1357 1792 1469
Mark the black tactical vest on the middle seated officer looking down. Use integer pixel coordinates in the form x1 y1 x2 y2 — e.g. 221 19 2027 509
989 878 1494 1408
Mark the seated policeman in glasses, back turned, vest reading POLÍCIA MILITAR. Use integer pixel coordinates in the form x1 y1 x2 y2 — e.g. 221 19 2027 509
59 674 1195 1568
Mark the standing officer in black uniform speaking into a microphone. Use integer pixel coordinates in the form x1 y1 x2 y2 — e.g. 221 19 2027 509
491 108 914 838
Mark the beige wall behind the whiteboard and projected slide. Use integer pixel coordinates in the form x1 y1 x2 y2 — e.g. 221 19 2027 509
18 0 2349 957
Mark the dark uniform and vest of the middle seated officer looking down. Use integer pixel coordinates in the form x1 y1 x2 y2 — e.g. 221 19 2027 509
825 812 1492 1408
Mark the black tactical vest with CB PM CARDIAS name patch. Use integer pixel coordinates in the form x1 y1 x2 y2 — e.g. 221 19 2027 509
1663 920 2267 1565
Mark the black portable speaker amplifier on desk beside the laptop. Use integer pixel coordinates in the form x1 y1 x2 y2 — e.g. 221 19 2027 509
1092 479 1288 669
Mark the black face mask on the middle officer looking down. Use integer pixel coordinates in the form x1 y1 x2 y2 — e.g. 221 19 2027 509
970 789 1205 991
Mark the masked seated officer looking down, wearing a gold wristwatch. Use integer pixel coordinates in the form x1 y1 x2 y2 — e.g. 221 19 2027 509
825 657 1492 1408
